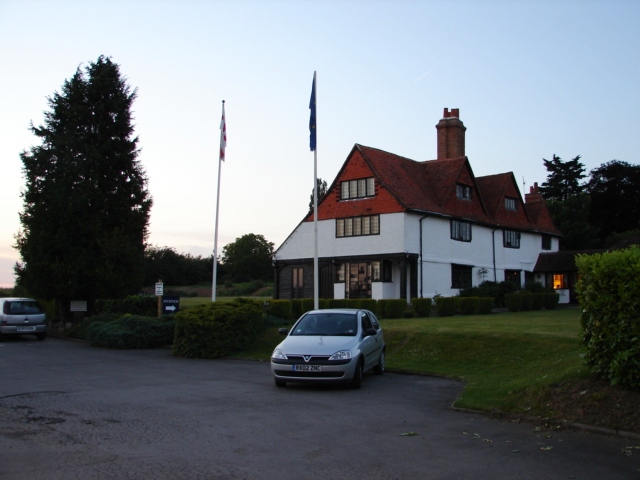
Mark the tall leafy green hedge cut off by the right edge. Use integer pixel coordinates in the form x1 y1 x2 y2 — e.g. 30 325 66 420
576 246 640 390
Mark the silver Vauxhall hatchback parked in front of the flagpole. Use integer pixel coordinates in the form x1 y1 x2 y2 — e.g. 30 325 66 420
271 309 385 388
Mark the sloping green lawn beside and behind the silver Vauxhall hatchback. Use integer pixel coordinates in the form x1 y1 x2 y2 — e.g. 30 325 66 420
232 308 586 413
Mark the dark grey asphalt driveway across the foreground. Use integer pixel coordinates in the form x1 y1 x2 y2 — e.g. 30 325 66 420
0 337 640 480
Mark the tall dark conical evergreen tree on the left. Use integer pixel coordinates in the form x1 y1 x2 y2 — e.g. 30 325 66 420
16 56 152 308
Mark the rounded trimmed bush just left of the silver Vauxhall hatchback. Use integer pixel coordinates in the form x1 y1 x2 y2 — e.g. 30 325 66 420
172 301 265 358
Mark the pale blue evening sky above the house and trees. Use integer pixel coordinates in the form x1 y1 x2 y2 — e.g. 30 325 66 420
0 0 640 287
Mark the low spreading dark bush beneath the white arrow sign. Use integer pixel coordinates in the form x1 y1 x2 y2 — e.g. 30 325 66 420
87 315 175 349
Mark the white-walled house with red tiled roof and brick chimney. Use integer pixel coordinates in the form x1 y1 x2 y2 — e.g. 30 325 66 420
273 109 560 301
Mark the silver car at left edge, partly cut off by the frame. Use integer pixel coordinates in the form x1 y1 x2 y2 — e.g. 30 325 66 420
0 298 47 340
